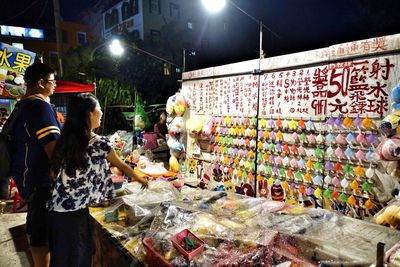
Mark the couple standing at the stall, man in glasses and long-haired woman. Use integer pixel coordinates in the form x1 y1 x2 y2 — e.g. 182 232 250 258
1 63 147 267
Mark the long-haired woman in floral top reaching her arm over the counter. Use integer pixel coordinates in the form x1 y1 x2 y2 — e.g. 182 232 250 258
48 93 147 267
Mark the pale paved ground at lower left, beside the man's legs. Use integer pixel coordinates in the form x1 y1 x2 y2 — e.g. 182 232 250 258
0 203 33 267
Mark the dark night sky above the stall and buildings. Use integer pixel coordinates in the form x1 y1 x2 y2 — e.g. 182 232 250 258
0 0 400 67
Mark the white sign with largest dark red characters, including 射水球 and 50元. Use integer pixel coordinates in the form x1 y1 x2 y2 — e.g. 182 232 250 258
324 56 399 117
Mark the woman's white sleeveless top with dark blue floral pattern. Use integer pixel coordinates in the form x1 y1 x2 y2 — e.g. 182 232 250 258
47 135 114 212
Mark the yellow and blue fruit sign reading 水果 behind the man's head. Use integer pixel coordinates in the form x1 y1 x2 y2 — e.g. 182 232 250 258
0 43 36 97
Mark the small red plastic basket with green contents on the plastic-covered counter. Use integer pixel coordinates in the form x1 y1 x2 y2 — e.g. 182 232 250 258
171 229 204 261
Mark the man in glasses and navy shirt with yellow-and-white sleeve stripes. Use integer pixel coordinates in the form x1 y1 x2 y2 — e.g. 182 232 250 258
11 63 61 266
